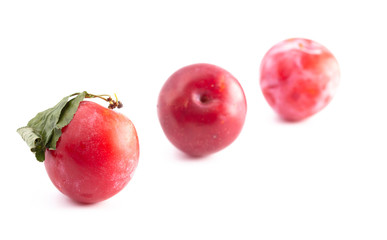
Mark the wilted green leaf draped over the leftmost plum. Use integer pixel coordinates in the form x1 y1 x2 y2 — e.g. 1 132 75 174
17 92 87 162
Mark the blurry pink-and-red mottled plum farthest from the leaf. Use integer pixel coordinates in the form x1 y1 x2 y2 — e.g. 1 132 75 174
260 38 340 121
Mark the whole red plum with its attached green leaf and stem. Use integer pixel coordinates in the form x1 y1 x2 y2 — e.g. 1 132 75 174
17 92 139 203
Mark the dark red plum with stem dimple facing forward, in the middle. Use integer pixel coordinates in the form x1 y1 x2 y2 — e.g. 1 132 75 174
157 63 247 157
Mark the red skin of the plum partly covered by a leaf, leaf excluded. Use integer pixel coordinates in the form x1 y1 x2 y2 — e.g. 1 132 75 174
44 101 139 203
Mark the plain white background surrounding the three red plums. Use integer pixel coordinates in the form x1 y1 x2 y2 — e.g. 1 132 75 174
0 0 387 240
